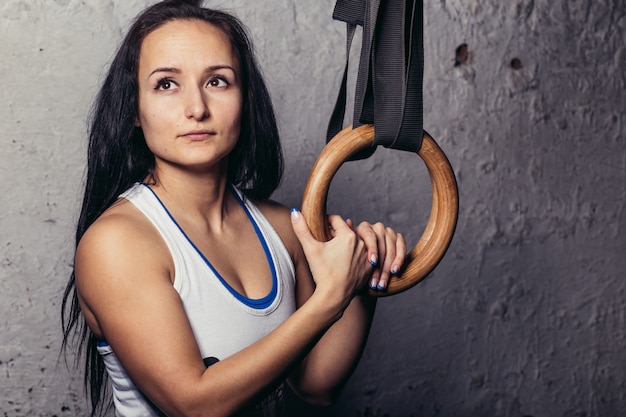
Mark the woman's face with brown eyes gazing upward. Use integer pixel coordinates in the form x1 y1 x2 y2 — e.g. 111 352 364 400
136 20 243 172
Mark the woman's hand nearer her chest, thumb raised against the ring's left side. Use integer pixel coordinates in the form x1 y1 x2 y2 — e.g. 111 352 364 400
291 209 374 310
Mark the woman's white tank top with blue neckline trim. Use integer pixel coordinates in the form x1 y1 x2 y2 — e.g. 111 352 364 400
98 183 296 417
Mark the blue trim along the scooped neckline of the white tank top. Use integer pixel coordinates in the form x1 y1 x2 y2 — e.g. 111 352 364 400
140 182 278 310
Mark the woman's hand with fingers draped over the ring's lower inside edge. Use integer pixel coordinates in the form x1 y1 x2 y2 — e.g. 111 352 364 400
347 219 406 291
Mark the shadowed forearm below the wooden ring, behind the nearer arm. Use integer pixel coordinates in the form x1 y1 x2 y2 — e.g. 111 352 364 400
290 295 376 404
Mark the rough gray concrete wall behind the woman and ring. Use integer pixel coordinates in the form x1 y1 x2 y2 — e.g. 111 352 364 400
0 0 626 417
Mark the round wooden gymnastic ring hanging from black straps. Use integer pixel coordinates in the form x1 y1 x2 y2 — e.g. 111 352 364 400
302 125 459 296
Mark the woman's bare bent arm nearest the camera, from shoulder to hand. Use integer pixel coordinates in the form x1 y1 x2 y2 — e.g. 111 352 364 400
75 203 372 416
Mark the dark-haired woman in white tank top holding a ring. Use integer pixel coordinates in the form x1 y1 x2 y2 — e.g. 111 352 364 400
63 0 406 416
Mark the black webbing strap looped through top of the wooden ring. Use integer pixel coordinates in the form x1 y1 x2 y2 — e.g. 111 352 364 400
326 0 424 159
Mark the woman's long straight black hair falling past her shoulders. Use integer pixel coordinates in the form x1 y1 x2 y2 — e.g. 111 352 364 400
61 0 283 416
